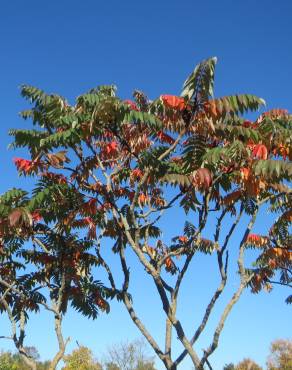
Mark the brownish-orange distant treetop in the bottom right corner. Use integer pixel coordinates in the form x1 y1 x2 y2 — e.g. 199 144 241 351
267 339 292 370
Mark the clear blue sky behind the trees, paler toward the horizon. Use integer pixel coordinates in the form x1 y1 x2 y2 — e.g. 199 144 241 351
0 0 292 370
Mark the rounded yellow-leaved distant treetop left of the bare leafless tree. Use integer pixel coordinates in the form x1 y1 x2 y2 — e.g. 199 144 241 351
62 346 102 370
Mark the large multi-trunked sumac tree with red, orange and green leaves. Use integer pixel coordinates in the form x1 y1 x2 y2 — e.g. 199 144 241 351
2 58 292 370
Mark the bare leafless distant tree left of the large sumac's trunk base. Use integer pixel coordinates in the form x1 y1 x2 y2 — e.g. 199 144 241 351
105 340 155 370
